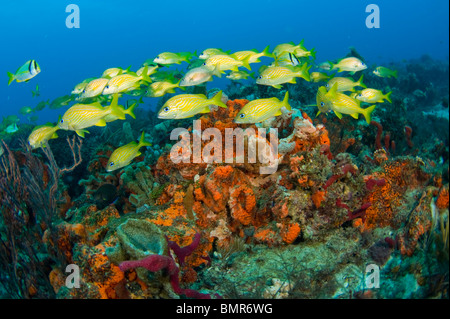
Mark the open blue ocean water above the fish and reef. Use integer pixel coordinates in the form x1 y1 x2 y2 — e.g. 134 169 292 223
0 0 449 123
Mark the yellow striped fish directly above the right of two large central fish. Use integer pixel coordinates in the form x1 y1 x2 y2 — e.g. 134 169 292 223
256 63 311 89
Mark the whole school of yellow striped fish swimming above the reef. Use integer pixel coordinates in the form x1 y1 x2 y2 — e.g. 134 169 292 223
8 41 397 171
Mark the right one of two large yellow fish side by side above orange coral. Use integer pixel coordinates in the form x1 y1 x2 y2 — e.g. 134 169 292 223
234 92 291 124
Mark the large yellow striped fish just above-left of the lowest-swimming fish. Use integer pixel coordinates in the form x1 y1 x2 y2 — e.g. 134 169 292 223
58 94 125 137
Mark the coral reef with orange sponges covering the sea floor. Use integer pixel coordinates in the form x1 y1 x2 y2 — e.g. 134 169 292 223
0 53 449 299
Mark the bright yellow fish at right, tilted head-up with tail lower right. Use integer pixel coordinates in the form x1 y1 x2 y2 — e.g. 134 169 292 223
327 83 375 124
